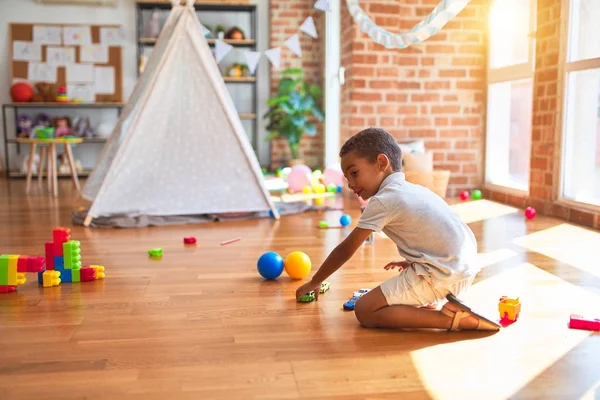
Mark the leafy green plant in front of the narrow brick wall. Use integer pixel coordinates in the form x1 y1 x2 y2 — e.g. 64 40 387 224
263 68 324 159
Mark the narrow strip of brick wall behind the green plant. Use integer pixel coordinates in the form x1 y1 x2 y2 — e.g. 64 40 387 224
269 0 325 168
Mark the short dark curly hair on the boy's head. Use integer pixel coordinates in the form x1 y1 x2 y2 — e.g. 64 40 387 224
340 128 402 172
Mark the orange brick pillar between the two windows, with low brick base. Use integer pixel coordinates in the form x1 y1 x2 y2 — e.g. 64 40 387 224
484 0 600 228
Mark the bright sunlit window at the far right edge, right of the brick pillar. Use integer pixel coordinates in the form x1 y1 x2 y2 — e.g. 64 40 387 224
561 0 600 205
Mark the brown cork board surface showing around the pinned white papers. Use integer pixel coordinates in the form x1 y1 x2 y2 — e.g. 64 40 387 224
10 24 123 103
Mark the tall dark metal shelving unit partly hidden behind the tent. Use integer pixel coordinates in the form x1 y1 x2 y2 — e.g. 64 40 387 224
136 0 258 152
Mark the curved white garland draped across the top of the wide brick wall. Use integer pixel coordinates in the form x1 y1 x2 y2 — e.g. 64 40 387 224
344 0 471 49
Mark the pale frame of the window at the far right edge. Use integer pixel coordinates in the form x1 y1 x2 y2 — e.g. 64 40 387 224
552 0 600 212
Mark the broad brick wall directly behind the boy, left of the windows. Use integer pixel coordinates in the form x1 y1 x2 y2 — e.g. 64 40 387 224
341 0 487 196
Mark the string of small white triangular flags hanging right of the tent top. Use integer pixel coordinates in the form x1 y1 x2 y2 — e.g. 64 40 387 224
212 0 330 74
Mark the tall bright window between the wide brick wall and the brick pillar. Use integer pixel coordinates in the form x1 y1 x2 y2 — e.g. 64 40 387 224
485 0 536 191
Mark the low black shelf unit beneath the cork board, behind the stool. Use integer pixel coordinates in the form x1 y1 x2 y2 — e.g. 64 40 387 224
2 103 123 178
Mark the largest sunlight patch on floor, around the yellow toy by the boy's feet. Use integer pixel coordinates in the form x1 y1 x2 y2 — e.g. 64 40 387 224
411 263 600 399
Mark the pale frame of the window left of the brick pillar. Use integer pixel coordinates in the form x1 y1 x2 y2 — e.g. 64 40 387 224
483 0 537 196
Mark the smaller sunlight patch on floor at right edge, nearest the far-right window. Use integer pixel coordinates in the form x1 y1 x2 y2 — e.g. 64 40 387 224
514 224 600 277
